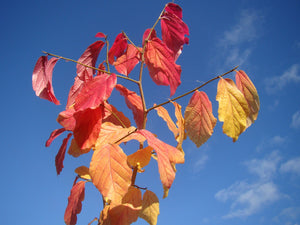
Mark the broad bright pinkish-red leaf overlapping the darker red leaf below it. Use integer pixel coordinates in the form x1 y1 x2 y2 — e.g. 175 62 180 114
74 74 117 111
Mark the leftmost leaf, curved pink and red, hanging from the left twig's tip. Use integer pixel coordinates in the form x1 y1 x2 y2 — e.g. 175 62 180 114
32 56 60 105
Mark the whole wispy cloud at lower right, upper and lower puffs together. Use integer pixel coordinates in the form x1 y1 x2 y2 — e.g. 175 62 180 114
215 151 282 219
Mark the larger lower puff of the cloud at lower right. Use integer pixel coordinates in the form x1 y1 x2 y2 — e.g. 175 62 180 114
215 181 281 219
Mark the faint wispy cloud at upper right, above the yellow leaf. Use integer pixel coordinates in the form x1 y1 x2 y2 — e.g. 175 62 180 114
218 10 261 66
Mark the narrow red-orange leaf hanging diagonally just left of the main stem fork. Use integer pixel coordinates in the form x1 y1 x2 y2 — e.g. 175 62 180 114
116 84 144 129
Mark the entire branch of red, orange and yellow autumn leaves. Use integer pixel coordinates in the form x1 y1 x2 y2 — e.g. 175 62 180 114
32 3 259 225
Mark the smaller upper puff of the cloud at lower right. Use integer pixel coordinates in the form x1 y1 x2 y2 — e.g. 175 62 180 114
245 151 281 180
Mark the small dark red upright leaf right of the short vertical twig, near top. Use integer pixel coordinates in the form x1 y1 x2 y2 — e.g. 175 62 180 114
108 33 127 64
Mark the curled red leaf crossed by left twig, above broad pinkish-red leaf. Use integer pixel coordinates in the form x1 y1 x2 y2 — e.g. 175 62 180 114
76 41 105 80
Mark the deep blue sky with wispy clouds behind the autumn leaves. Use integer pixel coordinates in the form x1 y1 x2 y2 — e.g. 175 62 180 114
0 0 300 225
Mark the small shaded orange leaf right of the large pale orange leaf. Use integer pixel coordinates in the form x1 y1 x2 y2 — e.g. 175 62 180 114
127 146 153 172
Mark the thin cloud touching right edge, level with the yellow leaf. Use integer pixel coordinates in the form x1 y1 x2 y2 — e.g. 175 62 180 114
265 64 300 94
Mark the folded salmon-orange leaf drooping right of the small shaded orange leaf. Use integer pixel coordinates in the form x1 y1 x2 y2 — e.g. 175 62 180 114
137 130 184 188
